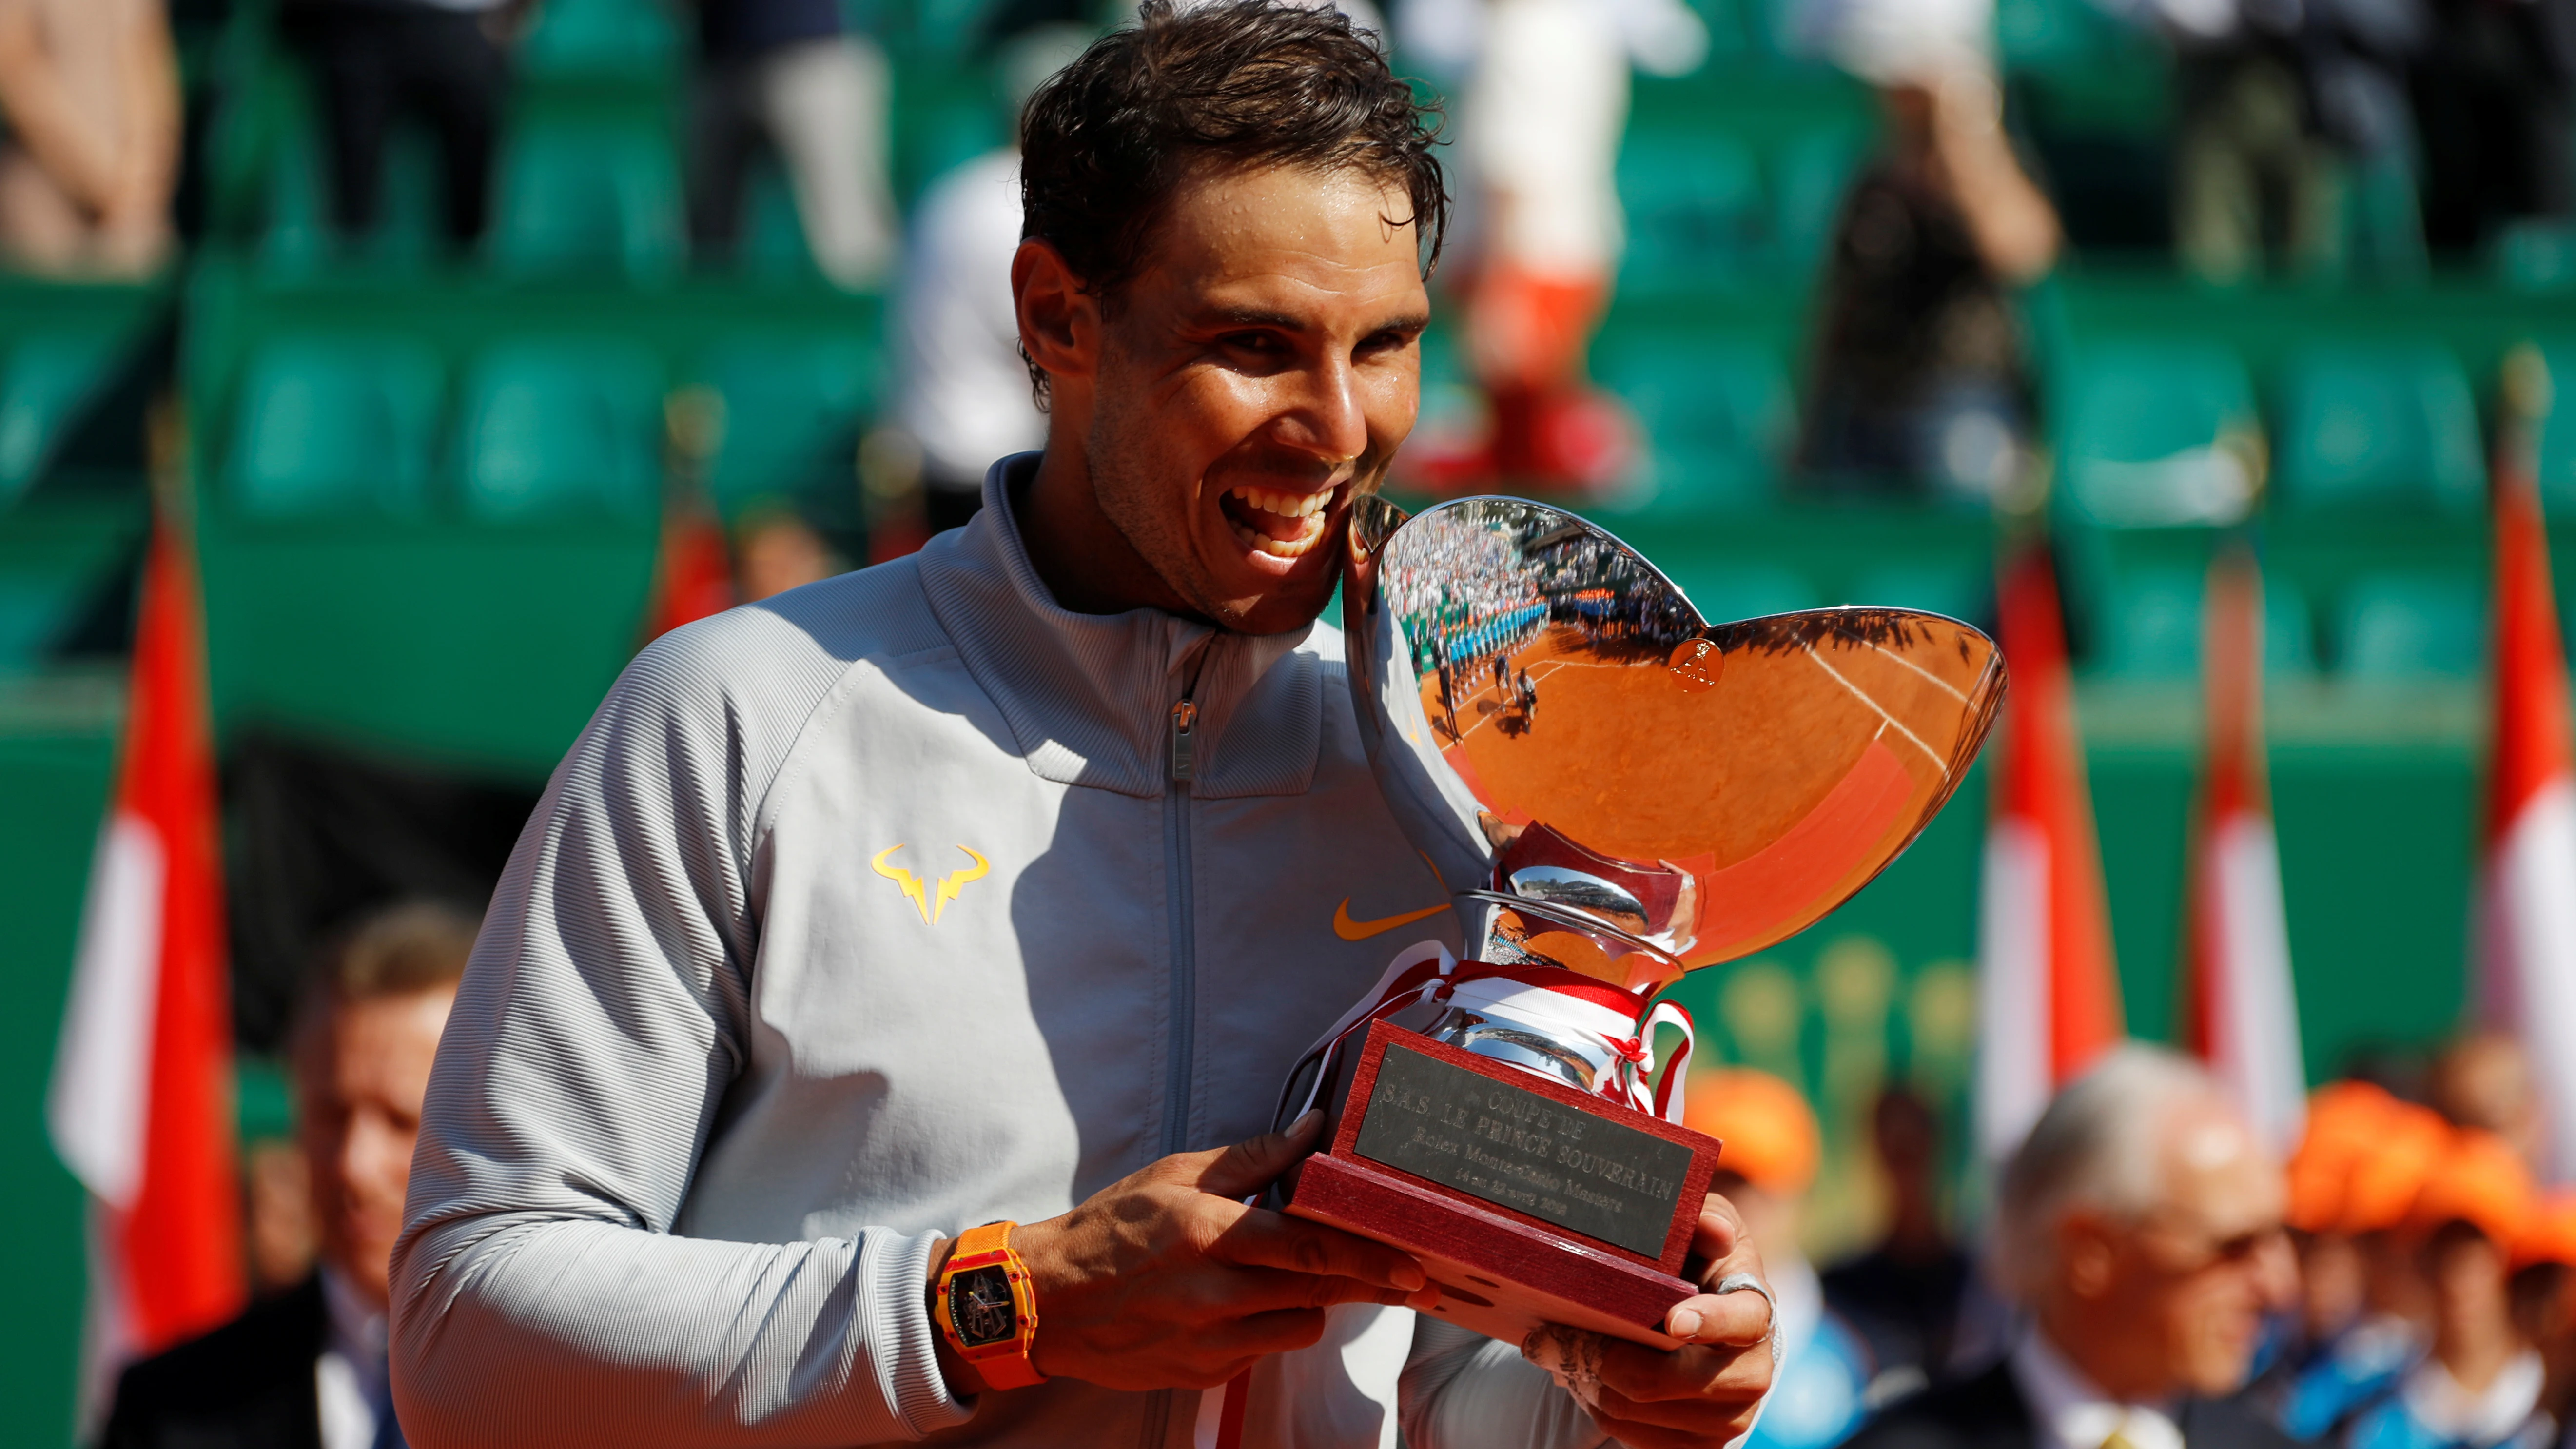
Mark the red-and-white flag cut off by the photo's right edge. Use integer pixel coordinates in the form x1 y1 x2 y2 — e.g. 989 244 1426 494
2476 369 2576 1181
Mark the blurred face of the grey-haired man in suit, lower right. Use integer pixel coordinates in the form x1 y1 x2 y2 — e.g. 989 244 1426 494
2097 1101 2298 1395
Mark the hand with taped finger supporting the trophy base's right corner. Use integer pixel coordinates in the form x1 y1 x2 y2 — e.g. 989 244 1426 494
1522 1194 1775 1449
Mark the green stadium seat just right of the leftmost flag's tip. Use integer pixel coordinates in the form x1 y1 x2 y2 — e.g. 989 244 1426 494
227 338 443 518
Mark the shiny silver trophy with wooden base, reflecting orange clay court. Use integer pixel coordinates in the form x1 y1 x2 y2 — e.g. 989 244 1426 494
1278 498 2004 1346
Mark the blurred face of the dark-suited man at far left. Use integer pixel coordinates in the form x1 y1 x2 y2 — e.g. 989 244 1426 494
296 987 456 1302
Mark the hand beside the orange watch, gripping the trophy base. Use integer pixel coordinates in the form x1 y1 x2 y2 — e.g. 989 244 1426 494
933 1111 1453 1392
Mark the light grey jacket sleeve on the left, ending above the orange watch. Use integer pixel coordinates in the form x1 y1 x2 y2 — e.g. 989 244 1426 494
391 608 971 1449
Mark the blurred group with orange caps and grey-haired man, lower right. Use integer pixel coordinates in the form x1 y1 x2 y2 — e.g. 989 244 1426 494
1690 1034 2576 1449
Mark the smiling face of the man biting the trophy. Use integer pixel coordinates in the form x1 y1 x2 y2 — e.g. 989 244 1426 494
1087 165 1430 634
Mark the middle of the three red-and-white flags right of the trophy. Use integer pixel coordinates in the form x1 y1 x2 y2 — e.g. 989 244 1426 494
2182 549 2308 1153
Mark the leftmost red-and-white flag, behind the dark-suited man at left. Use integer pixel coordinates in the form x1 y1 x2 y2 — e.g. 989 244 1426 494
46 526 245 1405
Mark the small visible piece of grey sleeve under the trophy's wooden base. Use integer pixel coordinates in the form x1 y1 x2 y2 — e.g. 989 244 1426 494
1396 1312 1610 1449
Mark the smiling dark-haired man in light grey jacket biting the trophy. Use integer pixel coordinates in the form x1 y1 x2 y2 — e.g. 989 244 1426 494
394 2 1770 1449
